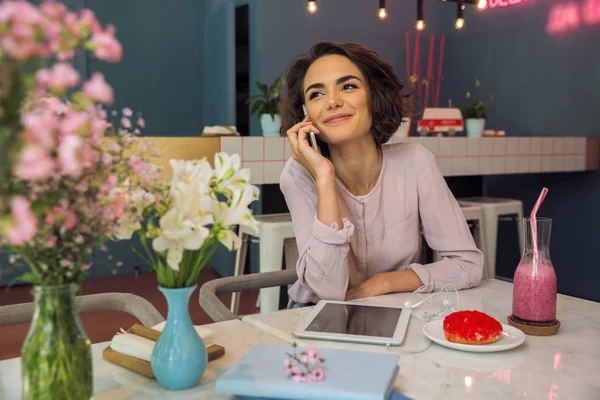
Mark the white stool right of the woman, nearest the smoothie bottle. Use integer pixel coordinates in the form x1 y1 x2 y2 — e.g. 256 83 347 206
458 197 523 278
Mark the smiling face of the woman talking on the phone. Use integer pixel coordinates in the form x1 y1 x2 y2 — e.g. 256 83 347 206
303 55 371 144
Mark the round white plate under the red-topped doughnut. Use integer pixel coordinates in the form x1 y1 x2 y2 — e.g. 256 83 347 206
423 319 525 353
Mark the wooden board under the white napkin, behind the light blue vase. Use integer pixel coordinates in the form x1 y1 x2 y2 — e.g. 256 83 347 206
102 324 225 379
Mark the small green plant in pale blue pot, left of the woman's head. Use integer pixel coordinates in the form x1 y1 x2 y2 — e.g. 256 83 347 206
248 76 284 136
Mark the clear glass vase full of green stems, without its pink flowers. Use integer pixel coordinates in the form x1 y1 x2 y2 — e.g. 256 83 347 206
21 284 93 400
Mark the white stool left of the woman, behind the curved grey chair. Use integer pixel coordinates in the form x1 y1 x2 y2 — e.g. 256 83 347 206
230 214 298 315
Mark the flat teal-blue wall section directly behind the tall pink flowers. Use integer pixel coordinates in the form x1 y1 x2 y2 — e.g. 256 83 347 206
86 0 205 136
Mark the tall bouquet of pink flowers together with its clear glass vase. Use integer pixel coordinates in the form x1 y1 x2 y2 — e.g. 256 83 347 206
0 1 155 399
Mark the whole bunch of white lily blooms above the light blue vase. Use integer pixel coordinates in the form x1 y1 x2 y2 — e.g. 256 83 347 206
117 153 259 284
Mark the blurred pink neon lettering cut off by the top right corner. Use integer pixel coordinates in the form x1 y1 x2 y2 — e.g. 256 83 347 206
546 0 600 34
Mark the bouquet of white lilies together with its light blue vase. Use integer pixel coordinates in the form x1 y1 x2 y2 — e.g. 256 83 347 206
118 153 259 390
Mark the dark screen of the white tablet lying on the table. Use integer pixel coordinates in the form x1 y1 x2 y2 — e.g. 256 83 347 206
305 303 402 338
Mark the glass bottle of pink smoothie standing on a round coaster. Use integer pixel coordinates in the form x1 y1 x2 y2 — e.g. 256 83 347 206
512 218 556 325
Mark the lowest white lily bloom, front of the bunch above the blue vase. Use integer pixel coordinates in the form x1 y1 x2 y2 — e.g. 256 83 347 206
152 208 210 271
